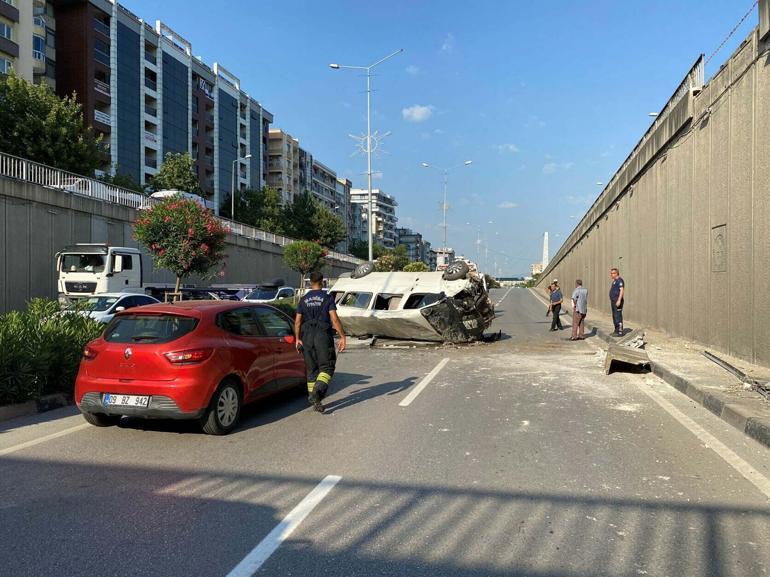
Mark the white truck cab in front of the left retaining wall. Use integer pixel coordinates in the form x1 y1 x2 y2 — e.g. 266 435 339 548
56 244 142 302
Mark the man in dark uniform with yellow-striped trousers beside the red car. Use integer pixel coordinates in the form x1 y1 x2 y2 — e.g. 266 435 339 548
294 272 345 413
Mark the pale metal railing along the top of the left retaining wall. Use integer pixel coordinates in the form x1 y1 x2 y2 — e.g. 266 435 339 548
0 152 363 264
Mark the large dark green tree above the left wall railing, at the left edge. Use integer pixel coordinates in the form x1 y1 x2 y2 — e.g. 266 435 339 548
0 71 102 176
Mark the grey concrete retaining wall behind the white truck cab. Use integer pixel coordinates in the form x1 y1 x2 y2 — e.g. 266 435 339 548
0 178 353 312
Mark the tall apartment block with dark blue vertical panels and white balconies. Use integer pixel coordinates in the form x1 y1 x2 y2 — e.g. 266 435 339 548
49 0 273 213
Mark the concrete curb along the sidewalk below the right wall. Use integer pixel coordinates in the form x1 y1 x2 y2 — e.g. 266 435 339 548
533 291 770 448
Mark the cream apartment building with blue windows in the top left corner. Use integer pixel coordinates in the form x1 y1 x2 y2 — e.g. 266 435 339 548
0 0 56 88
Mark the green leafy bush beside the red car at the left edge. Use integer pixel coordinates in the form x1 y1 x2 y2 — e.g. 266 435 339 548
0 299 104 405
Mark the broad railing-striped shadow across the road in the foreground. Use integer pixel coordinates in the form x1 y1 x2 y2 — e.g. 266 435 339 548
0 460 770 577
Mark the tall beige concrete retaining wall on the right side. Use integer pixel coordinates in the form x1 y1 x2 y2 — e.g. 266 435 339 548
540 31 770 365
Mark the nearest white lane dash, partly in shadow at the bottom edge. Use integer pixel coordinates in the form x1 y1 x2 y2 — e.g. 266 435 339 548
227 475 342 577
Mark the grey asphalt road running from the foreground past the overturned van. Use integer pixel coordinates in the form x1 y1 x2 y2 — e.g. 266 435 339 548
0 289 770 577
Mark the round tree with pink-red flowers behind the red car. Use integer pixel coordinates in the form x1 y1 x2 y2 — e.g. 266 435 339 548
134 196 229 293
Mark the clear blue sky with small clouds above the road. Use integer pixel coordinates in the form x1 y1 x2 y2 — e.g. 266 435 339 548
123 0 757 275
